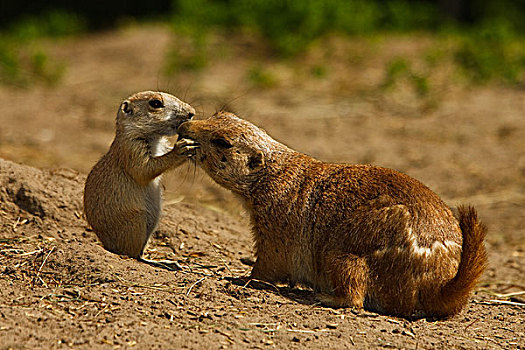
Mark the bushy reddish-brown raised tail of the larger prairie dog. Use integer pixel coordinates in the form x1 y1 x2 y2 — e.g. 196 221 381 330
428 206 487 317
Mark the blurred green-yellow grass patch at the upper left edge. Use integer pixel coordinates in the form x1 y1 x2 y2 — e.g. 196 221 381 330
0 11 84 86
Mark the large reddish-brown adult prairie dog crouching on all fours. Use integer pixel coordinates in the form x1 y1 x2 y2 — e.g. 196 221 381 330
178 112 487 318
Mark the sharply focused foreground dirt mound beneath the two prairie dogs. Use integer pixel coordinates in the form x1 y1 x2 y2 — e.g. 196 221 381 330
0 159 523 349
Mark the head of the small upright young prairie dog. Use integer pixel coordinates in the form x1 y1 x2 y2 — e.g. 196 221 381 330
117 91 195 138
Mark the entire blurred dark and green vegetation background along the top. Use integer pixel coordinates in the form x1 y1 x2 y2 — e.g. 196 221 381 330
0 0 525 87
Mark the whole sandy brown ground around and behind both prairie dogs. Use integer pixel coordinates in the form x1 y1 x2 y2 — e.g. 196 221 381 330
0 26 525 349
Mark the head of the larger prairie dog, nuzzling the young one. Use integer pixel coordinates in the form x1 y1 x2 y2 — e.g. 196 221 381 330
177 112 284 194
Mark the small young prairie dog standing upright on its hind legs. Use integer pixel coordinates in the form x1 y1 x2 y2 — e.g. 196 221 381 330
84 91 195 262
